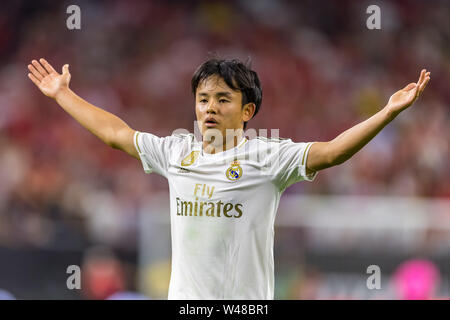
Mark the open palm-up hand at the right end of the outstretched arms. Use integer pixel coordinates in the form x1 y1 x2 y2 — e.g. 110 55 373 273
386 69 431 114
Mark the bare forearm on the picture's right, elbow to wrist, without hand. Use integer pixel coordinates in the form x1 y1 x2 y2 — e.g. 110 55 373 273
328 107 396 166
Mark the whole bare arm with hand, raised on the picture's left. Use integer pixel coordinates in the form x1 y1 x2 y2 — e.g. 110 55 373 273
28 59 139 159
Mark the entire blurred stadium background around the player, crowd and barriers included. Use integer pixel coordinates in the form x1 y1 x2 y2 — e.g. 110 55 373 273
0 0 450 299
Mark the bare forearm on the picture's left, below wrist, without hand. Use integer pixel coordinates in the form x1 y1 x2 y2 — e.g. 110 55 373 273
55 88 128 146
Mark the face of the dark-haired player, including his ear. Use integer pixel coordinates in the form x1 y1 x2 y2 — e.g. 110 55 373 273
195 75 255 143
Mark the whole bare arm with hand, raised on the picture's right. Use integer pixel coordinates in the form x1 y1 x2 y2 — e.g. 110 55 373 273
306 69 431 172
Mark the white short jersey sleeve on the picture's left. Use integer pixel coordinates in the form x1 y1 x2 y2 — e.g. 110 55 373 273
133 131 182 177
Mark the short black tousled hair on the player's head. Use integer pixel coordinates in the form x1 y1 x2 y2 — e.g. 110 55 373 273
191 58 262 129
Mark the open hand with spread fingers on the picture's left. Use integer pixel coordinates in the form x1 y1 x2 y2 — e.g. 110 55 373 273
28 59 70 99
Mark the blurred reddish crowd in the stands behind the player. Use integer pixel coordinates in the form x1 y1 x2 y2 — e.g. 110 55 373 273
0 0 450 298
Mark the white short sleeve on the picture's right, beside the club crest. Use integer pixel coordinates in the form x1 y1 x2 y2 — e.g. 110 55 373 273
270 139 317 189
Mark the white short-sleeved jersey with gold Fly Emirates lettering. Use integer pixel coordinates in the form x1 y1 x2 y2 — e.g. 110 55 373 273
134 132 317 299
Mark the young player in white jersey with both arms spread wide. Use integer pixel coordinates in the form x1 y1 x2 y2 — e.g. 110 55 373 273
28 59 430 299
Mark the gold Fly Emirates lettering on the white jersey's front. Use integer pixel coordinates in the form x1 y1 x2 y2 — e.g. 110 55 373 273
176 183 243 218
